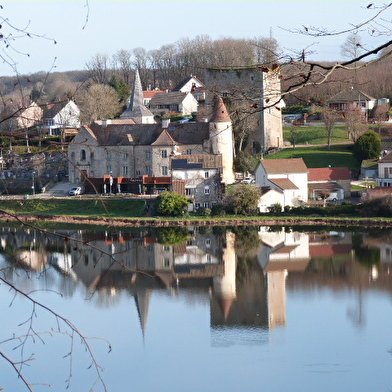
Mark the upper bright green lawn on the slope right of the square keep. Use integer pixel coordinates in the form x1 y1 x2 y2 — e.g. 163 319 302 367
283 123 350 145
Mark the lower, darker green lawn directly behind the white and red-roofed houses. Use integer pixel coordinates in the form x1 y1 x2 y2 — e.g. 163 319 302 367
264 144 360 170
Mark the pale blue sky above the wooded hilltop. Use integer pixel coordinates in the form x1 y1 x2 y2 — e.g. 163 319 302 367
0 0 386 76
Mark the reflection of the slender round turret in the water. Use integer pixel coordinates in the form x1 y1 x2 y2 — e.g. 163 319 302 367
213 232 237 319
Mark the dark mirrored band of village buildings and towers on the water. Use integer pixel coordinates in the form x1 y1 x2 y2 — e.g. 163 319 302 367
0 227 392 339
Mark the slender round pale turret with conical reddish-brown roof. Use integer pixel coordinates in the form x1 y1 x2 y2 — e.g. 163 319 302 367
210 98 235 185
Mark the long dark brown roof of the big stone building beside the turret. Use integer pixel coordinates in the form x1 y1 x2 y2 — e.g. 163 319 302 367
90 123 209 146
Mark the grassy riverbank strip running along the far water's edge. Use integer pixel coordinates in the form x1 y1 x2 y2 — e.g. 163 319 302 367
0 198 392 228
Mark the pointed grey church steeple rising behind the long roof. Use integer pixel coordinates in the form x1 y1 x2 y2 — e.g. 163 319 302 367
120 69 155 124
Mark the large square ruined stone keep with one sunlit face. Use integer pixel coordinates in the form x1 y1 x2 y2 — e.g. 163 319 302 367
204 66 283 153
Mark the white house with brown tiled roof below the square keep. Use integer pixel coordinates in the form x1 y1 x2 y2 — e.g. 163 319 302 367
255 158 308 208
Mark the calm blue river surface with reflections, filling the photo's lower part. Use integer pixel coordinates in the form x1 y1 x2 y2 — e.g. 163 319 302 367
0 227 392 392
